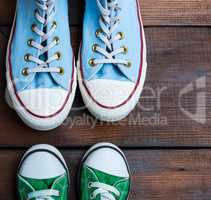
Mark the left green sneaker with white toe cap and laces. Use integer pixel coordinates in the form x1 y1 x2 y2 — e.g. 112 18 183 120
17 145 69 200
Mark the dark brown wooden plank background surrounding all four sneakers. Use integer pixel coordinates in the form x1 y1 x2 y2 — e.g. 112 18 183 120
0 0 211 200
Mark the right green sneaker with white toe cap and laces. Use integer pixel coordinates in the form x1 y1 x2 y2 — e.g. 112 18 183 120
78 143 131 200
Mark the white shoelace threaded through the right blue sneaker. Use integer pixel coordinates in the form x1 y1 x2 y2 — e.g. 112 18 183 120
92 0 131 66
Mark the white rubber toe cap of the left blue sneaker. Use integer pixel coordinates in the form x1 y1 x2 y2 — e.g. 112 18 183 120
18 88 68 116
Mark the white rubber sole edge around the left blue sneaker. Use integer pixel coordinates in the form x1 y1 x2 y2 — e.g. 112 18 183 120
5 9 77 131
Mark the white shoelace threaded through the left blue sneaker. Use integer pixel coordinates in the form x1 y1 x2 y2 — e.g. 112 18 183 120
25 0 61 74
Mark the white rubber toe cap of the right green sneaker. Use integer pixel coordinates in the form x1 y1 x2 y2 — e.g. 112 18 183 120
84 147 129 177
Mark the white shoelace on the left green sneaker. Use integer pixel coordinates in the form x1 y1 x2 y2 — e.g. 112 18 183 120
27 189 59 200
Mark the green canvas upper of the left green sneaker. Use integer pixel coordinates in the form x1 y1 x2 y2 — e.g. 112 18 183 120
17 175 69 200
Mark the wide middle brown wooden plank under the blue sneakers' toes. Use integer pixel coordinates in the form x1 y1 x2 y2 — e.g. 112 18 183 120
0 28 211 147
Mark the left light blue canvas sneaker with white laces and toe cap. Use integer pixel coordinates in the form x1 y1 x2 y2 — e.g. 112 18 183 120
6 0 76 130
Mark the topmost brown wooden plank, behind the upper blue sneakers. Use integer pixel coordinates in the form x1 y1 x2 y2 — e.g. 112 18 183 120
0 0 211 26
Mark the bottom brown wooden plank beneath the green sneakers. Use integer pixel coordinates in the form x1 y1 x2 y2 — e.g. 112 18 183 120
0 150 211 200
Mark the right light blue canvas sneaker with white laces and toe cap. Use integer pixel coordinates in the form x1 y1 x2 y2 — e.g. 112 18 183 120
78 0 147 121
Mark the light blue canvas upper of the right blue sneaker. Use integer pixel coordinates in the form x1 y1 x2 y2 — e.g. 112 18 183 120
81 0 143 82
